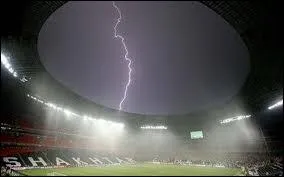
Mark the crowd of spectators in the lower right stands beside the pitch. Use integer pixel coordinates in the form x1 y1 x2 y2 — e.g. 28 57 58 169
153 153 283 176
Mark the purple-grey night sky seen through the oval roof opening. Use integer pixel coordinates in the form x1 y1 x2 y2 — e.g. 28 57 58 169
38 1 249 115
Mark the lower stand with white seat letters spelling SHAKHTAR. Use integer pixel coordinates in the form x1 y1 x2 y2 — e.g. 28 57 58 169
1 147 134 169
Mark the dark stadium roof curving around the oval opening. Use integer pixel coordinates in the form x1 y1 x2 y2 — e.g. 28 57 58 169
1 1 284 121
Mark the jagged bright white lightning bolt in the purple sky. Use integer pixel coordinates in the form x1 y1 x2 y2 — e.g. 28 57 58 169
112 1 132 110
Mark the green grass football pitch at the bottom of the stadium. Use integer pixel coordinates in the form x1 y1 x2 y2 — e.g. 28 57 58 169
21 164 240 176
